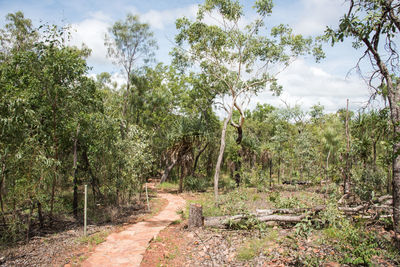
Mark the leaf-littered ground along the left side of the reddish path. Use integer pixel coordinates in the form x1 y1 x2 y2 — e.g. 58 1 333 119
0 184 168 267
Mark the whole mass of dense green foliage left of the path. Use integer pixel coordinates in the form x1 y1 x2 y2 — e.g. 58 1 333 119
0 12 159 242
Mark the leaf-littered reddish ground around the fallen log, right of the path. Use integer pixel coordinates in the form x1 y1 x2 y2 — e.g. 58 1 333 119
140 185 400 267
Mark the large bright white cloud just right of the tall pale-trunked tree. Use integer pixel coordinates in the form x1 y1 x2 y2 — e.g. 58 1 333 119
250 60 370 112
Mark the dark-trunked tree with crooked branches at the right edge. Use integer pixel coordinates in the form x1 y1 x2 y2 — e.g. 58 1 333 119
325 0 400 240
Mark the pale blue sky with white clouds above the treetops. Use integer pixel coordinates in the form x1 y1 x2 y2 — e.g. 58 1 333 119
0 0 382 112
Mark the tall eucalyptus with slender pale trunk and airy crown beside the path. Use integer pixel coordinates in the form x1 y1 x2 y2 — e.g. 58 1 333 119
174 0 322 199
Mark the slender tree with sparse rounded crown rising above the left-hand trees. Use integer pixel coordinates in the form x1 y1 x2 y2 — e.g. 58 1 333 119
104 14 157 130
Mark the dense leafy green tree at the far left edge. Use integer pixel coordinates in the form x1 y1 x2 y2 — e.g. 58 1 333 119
0 18 95 237
